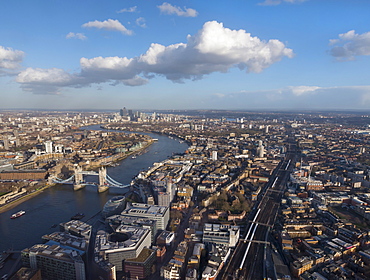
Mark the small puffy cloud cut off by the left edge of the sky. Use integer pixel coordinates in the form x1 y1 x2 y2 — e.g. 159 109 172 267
0 46 24 76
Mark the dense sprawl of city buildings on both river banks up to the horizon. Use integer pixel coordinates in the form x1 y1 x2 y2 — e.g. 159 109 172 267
0 110 370 280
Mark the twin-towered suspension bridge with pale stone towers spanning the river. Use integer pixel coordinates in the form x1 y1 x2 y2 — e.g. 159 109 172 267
49 165 131 192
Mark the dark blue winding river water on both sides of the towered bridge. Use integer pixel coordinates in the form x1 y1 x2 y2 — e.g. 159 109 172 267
0 125 188 252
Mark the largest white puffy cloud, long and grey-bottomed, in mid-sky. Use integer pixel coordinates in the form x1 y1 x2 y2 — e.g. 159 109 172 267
17 21 293 94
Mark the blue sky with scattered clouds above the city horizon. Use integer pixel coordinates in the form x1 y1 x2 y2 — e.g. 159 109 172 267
0 0 370 110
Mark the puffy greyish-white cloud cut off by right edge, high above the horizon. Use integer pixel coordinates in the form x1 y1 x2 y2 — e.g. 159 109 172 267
329 30 370 60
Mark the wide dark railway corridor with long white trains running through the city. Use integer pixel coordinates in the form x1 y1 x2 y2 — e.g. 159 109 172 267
217 144 297 280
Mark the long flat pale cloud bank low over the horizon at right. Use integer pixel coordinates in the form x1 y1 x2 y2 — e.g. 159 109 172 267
204 86 370 110
